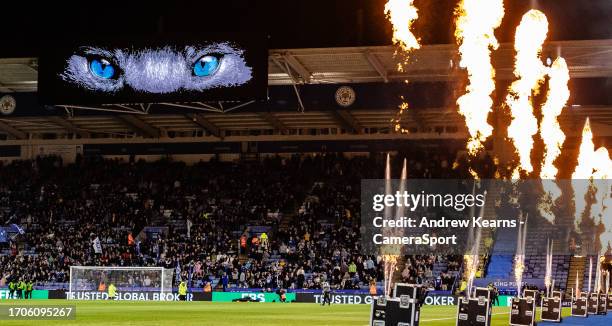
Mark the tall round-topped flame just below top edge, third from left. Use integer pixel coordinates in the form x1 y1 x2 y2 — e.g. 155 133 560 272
506 9 548 179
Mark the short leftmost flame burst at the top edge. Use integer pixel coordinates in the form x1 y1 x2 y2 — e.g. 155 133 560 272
385 0 421 52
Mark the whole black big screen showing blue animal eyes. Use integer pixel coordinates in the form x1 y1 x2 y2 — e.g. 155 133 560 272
38 35 268 105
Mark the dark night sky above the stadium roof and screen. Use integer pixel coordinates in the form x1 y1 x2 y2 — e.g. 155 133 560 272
0 0 612 57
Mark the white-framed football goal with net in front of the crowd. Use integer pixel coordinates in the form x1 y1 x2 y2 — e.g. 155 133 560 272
67 266 174 300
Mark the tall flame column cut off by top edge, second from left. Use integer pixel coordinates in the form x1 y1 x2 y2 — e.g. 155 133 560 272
455 0 504 155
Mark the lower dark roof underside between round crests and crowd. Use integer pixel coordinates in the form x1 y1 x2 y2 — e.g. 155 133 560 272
0 106 612 140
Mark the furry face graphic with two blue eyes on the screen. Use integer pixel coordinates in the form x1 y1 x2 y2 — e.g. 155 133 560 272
60 43 253 94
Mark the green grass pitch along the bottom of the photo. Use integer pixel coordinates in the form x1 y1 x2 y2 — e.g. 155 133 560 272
0 300 569 326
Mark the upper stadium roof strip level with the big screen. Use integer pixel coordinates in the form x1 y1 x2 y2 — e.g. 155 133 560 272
0 40 612 92
